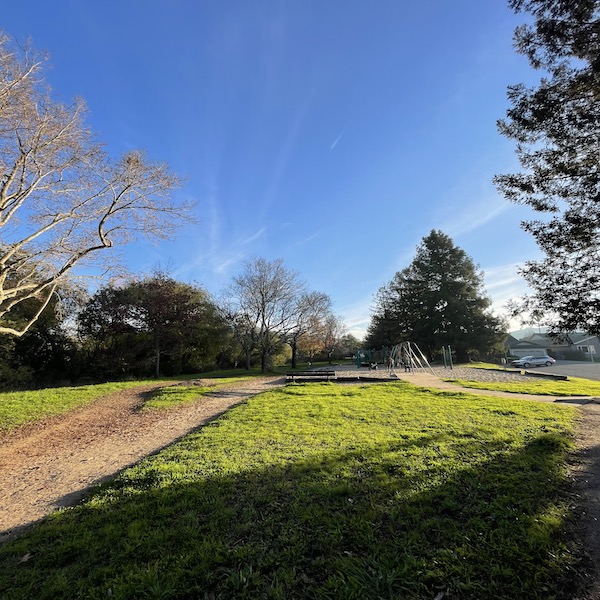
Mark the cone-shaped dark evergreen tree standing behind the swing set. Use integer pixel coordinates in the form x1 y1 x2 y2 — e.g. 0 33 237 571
366 230 505 362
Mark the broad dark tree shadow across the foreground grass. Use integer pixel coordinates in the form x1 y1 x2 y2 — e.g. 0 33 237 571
0 434 577 600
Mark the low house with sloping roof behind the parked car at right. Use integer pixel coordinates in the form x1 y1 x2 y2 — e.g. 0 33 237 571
505 331 600 361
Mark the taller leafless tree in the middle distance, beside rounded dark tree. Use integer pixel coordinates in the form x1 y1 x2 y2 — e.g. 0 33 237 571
229 258 304 373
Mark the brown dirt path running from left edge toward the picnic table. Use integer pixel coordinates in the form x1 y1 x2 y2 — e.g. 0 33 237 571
0 377 283 541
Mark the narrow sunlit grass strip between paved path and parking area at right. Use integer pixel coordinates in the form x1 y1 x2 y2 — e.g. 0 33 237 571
444 377 600 396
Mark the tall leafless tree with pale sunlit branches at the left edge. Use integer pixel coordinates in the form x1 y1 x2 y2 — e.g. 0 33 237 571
0 34 192 336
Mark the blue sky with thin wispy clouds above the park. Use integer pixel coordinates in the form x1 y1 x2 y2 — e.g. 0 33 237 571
0 0 539 337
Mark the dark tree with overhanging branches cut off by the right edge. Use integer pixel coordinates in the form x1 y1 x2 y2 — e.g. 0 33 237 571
495 0 600 334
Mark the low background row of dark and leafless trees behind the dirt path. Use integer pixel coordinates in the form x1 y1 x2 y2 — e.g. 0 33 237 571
0 258 359 388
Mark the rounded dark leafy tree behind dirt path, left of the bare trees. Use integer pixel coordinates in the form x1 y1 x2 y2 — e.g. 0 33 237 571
79 273 228 377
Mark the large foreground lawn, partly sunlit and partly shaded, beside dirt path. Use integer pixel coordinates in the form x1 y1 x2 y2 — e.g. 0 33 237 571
0 383 579 600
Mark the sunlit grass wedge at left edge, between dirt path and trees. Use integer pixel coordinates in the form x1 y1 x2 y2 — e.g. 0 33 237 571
0 381 164 431
